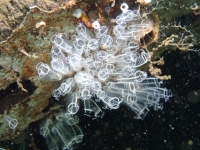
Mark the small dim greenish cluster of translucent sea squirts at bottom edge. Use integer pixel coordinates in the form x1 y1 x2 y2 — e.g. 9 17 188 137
40 114 83 150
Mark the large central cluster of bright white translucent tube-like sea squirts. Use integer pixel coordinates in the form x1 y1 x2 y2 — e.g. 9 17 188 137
36 3 172 119
